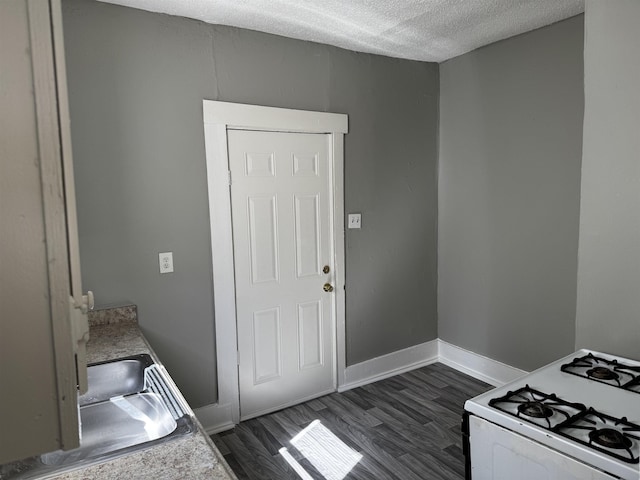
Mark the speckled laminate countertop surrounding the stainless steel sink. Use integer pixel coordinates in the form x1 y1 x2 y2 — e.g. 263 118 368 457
53 307 237 480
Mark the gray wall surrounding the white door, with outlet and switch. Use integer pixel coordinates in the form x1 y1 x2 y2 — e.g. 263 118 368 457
63 0 438 407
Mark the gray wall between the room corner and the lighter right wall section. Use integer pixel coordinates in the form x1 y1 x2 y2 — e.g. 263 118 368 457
438 16 583 370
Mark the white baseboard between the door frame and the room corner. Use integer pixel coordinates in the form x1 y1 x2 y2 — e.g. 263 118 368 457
338 340 438 392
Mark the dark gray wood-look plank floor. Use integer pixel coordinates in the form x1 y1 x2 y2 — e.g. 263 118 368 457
211 363 491 480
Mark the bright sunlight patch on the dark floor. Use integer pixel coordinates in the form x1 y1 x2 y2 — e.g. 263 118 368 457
280 420 362 480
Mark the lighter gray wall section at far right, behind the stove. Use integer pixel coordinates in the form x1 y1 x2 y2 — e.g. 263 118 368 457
576 0 640 360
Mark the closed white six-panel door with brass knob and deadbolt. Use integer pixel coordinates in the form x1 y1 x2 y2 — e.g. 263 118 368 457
228 130 336 419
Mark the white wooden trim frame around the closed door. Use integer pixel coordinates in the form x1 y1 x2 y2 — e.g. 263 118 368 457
203 100 348 424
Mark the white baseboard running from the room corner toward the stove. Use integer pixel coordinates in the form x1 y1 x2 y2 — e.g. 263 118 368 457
438 339 528 387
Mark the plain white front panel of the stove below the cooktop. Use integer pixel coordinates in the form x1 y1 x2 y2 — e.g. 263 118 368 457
468 415 618 480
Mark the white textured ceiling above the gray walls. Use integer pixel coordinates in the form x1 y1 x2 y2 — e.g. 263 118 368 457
96 0 584 62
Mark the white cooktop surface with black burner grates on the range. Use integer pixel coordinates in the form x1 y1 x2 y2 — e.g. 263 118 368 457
465 350 640 480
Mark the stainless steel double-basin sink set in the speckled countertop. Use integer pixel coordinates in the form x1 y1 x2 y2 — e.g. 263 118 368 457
0 354 195 480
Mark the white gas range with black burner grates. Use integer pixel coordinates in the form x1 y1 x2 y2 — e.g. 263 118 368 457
463 350 640 480
